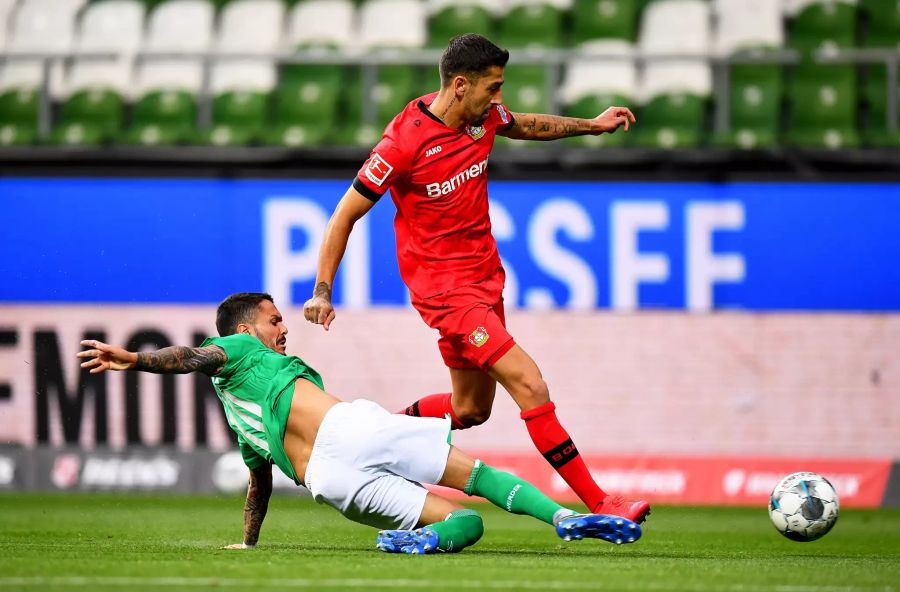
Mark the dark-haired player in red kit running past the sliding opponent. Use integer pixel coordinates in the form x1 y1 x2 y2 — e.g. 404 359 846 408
304 34 650 522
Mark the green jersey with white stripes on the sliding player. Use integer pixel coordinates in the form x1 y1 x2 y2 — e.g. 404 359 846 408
201 333 325 482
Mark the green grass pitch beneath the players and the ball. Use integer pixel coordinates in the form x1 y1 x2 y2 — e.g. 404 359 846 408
0 494 900 592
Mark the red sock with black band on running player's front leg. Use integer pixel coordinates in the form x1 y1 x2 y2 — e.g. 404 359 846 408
521 401 606 512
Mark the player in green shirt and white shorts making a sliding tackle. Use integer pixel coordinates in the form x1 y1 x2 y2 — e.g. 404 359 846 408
78 293 641 554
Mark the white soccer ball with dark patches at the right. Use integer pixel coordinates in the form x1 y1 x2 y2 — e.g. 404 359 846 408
769 472 840 543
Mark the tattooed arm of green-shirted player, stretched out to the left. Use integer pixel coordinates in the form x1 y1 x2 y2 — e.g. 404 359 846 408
78 339 228 376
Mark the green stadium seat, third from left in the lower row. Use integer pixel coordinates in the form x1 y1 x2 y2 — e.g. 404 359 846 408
122 90 197 145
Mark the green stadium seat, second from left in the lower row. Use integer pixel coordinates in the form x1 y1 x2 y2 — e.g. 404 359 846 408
51 89 125 145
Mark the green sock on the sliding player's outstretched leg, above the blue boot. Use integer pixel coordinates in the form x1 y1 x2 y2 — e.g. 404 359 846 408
463 460 575 525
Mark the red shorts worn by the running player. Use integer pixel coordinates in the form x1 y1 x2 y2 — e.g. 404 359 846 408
412 267 516 370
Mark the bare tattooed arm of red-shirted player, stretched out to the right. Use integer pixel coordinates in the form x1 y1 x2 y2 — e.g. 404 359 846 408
497 107 635 140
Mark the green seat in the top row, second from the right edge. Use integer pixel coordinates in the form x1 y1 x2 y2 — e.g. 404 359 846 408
788 0 857 54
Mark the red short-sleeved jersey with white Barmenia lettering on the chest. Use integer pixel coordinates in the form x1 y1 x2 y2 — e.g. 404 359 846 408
353 93 514 298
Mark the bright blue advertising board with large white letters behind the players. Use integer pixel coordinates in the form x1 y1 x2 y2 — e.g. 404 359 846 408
0 178 900 311
